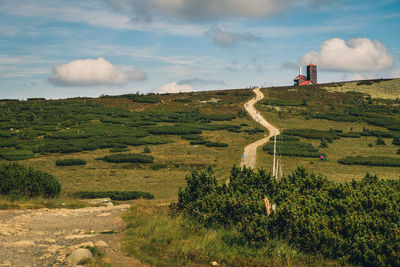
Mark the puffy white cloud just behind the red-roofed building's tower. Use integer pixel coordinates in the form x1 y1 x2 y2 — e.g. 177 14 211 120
300 38 394 72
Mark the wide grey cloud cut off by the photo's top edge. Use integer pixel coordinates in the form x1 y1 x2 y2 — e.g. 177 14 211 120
107 0 291 21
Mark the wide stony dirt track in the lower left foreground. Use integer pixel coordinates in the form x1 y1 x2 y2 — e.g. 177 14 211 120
0 204 142 266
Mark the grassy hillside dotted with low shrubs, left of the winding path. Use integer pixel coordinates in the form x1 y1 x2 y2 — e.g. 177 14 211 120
0 90 263 203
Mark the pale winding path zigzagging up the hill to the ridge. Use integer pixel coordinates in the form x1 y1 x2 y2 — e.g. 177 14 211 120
240 88 280 169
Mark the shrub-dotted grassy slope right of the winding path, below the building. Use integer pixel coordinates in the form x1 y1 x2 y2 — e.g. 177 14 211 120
257 80 400 182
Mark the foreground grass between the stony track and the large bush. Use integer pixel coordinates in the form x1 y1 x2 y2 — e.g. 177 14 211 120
124 201 338 266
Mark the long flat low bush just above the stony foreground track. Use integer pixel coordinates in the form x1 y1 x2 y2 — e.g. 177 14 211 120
73 191 154 201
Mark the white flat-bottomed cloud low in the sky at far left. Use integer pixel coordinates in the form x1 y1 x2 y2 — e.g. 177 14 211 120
48 57 147 86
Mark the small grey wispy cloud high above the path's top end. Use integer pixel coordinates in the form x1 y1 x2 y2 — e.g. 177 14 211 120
205 27 260 47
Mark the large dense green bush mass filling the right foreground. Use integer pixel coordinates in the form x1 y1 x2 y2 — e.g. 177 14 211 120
171 167 400 266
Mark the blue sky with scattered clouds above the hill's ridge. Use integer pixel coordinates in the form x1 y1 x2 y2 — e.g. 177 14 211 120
0 0 400 99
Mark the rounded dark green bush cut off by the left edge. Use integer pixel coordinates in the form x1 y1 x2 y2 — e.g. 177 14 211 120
0 163 61 198
